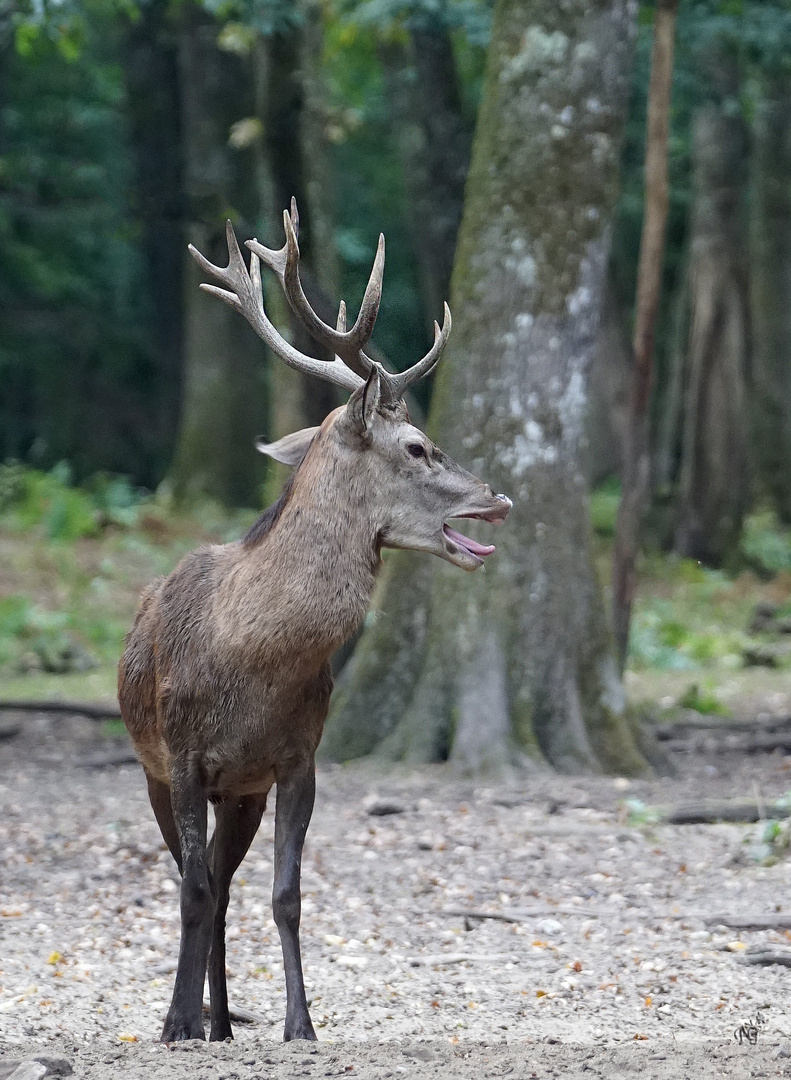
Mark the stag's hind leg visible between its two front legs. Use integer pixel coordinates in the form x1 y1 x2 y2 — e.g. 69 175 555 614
209 795 267 1042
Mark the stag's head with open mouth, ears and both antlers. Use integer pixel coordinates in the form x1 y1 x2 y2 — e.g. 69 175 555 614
189 200 511 570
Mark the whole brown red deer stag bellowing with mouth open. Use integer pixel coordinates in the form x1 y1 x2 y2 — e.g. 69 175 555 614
119 202 511 1041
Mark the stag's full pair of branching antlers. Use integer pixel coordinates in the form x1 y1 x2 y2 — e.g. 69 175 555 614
189 199 451 403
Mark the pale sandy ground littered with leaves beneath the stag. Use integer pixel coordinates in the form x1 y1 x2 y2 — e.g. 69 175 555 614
0 716 791 1080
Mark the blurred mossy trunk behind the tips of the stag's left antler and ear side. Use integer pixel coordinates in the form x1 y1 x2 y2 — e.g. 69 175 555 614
170 9 266 505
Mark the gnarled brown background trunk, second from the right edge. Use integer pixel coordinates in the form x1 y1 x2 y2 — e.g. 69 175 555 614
674 77 750 566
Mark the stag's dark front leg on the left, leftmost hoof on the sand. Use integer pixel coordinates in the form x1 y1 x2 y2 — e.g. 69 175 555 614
162 758 216 1042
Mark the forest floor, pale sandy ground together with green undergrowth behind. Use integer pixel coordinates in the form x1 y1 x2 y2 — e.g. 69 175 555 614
0 486 791 1080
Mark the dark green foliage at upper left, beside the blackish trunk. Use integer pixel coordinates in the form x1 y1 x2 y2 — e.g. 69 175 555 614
0 3 155 478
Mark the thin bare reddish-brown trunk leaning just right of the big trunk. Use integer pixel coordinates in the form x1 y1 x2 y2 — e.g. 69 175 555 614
613 0 679 672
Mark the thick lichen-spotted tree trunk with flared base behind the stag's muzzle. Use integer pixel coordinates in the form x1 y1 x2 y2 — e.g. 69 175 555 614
324 0 645 772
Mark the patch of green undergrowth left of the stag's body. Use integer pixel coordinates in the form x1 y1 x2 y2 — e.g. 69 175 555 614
0 463 255 700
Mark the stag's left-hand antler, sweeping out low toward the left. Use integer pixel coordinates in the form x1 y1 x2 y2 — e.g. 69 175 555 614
189 219 365 390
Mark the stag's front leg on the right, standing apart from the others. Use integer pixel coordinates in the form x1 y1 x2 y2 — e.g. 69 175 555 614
272 761 316 1042
